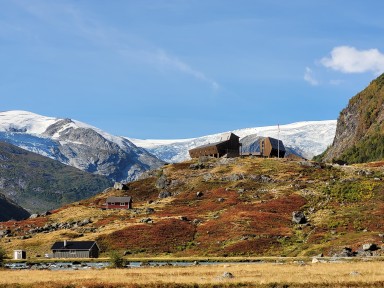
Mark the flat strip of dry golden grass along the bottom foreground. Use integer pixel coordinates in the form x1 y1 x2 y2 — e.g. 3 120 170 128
0 262 384 288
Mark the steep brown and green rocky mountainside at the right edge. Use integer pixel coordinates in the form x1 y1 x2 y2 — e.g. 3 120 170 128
322 74 384 163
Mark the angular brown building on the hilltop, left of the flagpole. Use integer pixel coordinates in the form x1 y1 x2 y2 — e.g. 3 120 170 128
189 133 241 158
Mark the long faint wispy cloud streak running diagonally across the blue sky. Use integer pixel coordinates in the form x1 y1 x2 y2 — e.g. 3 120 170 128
16 0 220 92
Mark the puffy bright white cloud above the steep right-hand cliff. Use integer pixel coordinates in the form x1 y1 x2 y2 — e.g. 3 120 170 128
320 46 384 74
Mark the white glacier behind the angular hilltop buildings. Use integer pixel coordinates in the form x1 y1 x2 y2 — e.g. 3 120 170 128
128 120 336 162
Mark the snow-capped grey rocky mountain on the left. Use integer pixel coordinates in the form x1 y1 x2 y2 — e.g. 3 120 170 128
0 111 163 181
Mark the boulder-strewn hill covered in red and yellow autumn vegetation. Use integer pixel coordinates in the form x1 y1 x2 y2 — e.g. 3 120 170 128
0 157 384 258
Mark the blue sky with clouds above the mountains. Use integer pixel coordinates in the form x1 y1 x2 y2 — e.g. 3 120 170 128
0 0 384 139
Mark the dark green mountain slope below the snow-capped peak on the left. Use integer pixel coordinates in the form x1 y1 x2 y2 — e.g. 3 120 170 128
0 142 112 214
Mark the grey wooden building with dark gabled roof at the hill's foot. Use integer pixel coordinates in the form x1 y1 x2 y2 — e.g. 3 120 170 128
51 240 100 258
